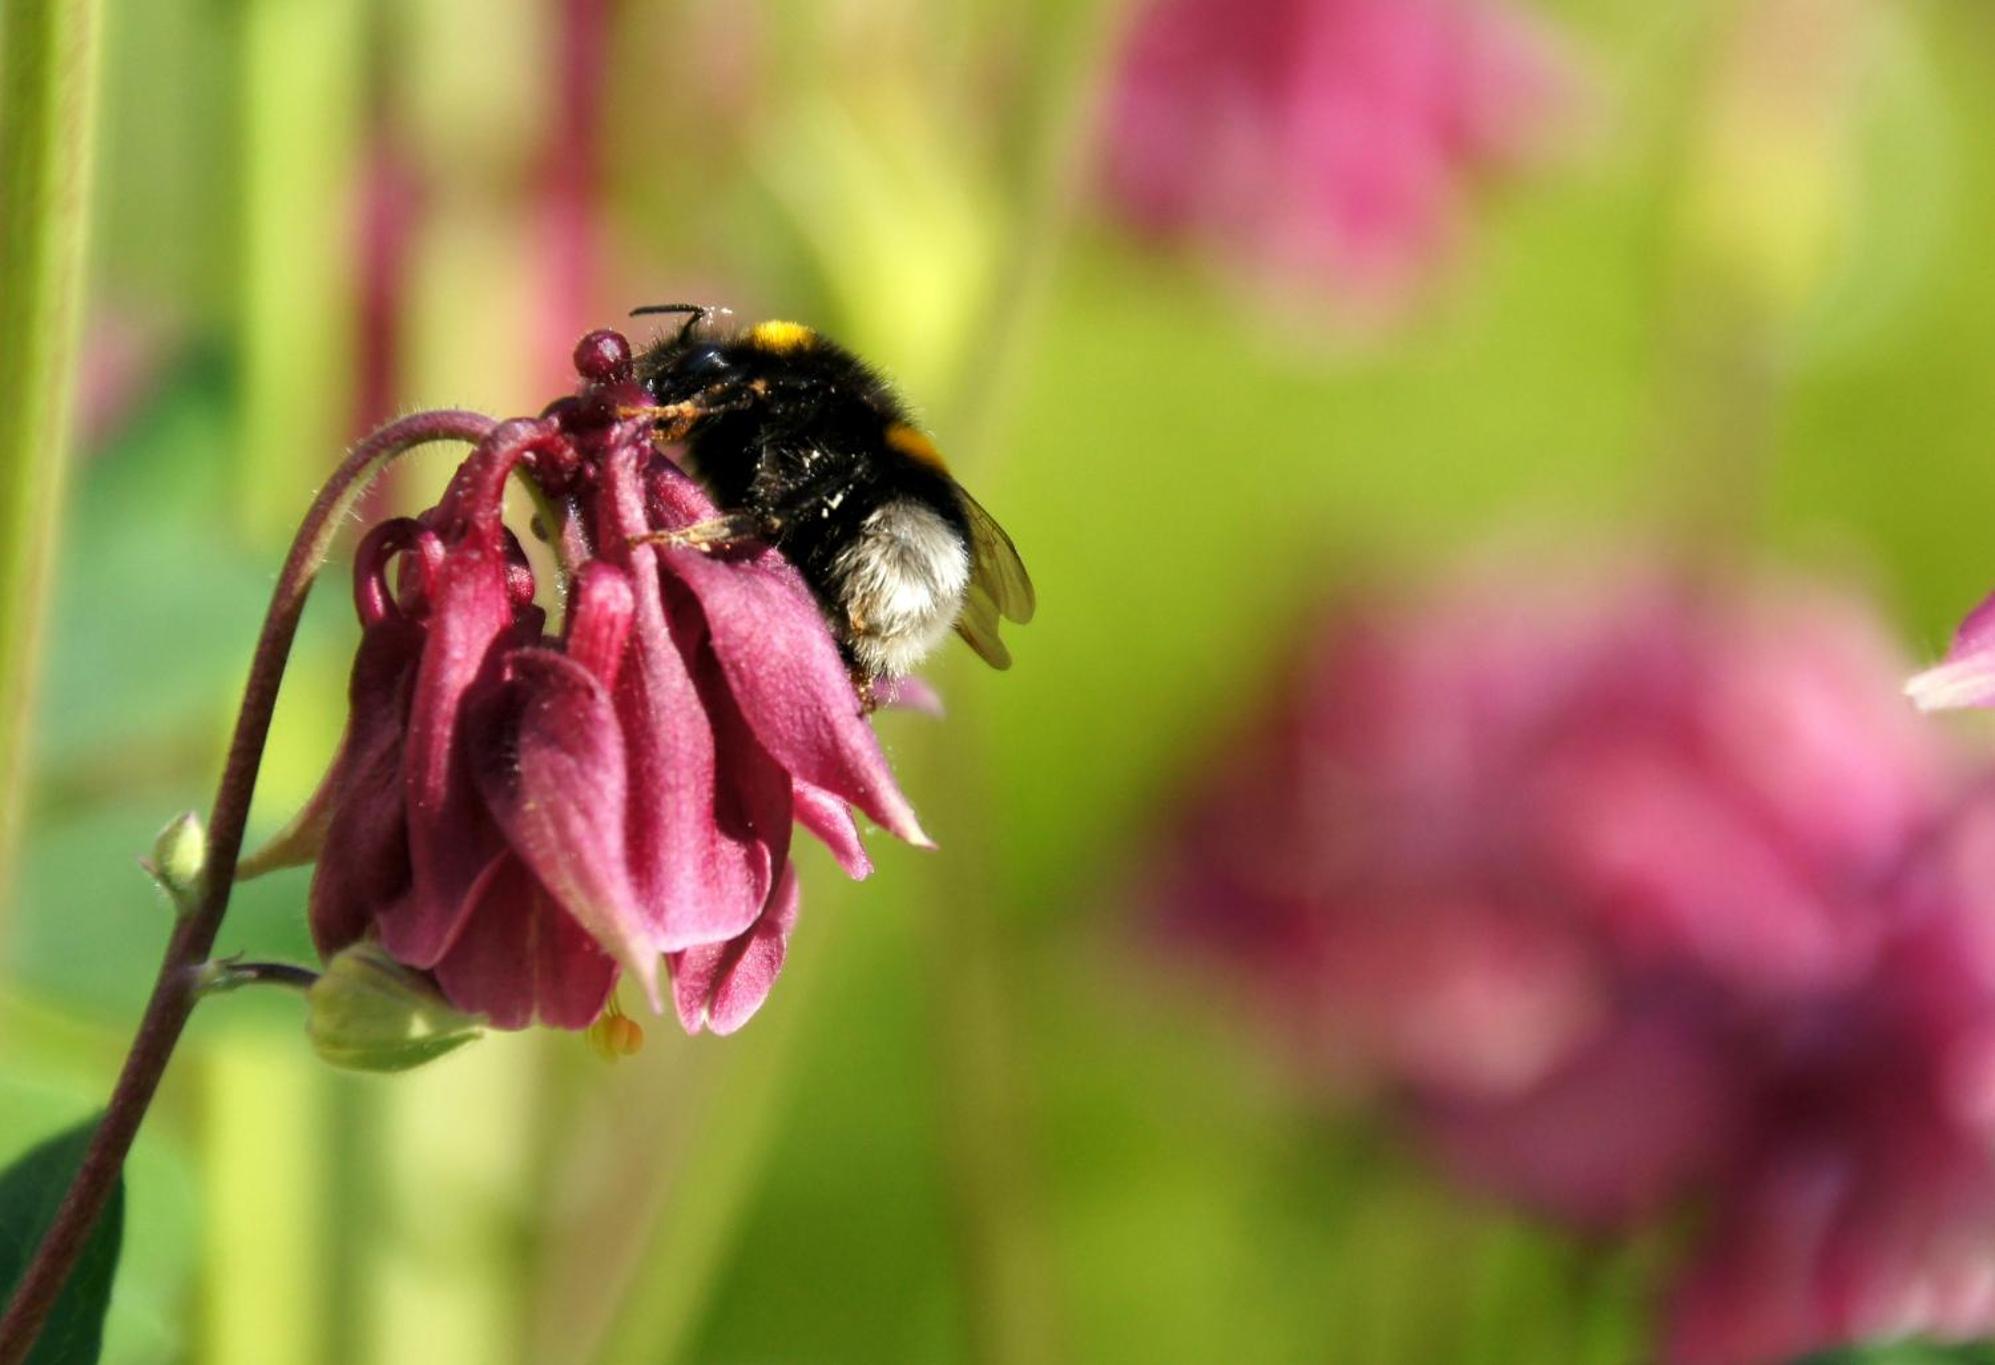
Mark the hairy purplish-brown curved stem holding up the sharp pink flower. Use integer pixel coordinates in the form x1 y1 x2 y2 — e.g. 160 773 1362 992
0 411 495 1365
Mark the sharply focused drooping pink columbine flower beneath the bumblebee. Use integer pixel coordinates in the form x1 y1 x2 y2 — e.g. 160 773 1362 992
271 333 926 1034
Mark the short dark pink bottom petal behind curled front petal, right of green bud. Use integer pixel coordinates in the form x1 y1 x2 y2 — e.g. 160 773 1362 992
437 854 616 1028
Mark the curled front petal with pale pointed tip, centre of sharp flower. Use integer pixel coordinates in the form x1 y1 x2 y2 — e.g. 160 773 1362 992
475 649 662 1008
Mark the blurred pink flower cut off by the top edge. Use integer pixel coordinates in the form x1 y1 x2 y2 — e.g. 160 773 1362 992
1103 0 1578 311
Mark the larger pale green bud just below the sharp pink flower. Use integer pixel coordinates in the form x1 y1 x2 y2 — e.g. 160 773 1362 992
305 940 483 1072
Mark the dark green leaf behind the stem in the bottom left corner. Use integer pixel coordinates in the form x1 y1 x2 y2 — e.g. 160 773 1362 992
0 1120 124 1365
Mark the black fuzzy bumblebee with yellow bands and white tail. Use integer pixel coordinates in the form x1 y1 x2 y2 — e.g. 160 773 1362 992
634 303 1033 694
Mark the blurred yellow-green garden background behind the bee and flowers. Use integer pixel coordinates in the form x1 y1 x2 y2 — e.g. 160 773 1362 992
0 0 1995 1365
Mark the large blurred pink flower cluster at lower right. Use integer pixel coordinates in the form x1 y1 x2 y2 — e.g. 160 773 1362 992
1157 569 1995 1365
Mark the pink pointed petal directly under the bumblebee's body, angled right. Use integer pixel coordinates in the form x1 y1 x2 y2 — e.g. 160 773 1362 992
660 549 932 848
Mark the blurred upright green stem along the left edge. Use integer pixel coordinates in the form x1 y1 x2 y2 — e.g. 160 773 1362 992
0 0 100 921
